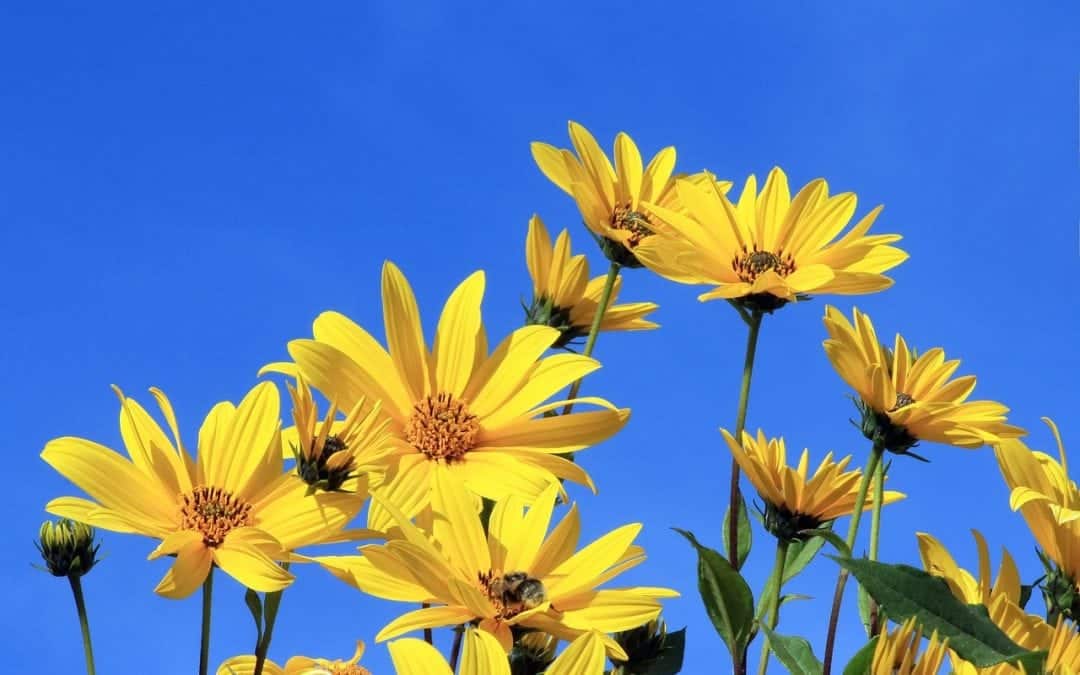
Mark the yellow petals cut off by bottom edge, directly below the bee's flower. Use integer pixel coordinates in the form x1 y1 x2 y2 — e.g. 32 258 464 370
390 629 606 675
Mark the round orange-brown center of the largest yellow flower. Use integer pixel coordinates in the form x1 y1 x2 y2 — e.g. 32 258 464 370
405 393 480 461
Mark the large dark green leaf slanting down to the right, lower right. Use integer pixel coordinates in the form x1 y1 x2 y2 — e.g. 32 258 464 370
831 556 1031 667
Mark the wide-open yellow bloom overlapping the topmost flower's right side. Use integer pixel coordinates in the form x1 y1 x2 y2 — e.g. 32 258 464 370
635 167 907 311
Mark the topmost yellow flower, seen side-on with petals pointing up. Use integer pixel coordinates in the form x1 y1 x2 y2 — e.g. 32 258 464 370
532 121 699 267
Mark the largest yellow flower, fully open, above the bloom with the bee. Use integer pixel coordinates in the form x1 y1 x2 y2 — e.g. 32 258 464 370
264 262 630 530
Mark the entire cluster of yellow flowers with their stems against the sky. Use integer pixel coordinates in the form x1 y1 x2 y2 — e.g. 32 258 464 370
33 122 1080 675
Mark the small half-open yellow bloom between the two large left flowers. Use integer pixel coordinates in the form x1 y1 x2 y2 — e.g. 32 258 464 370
281 377 395 492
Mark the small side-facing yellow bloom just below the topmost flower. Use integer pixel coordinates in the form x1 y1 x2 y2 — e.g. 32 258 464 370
525 216 657 347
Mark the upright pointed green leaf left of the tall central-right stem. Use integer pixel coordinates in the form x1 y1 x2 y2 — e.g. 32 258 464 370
674 528 754 661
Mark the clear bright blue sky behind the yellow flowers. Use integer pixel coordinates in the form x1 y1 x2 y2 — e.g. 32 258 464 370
0 2 1080 674
